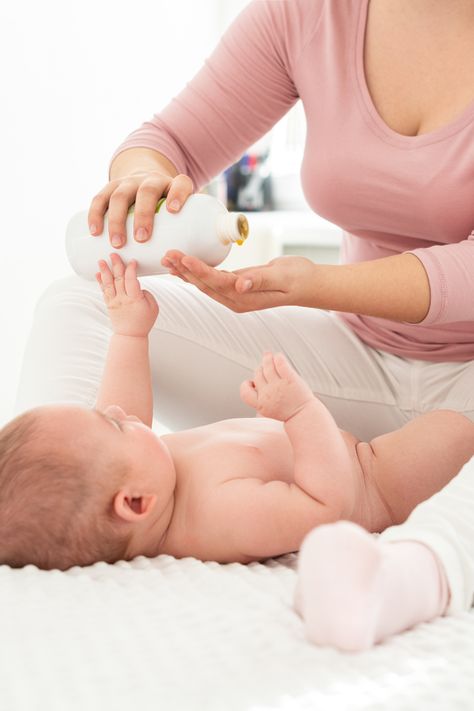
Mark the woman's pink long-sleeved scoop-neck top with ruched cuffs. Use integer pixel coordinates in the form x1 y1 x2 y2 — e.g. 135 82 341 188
113 0 474 361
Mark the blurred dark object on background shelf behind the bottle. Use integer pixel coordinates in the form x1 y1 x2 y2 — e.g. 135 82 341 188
224 151 274 212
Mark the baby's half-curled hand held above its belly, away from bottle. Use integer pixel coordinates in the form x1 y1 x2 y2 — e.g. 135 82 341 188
240 353 314 422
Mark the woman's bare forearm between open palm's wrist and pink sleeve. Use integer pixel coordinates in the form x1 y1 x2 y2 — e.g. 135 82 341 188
301 253 430 323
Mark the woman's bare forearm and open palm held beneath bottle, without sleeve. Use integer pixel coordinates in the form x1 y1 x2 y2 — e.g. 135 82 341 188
163 250 430 323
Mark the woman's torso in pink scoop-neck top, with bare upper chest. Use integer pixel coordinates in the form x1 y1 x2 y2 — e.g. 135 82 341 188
295 0 474 361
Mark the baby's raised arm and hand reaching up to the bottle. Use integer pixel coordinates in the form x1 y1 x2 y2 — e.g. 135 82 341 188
95 254 158 427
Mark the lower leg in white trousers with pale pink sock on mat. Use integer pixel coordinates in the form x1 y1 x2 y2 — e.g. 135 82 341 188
296 457 474 650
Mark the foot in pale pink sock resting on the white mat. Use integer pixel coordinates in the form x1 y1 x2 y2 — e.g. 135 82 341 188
295 521 448 651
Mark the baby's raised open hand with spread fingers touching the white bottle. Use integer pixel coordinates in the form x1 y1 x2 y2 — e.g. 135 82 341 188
95 253 159 336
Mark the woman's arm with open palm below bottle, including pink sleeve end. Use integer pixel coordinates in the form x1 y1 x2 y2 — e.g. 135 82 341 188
162 232 474 326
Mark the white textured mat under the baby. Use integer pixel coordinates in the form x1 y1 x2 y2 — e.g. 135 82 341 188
0 555 474 711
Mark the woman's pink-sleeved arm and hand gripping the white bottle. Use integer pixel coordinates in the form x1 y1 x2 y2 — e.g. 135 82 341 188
89 0 314 248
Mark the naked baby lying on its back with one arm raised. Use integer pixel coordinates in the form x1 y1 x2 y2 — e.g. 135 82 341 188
0 254 474 569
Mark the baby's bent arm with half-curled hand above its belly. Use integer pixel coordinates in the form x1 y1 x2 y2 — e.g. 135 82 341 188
241 353 359 517
